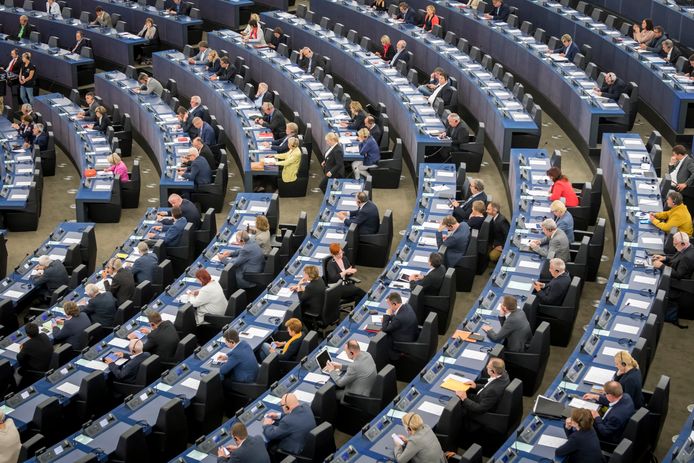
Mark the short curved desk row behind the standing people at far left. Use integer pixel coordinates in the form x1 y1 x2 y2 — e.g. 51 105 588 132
0 34 94 90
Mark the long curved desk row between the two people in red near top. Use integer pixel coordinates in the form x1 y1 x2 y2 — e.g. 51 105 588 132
311 0 540 164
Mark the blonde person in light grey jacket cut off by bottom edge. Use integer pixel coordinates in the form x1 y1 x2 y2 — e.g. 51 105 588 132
393 413 446 463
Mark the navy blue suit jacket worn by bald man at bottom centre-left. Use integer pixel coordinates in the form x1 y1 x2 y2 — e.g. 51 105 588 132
263 403 316 455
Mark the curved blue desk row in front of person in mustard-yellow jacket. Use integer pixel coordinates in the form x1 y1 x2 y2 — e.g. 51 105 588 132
494 134 665 461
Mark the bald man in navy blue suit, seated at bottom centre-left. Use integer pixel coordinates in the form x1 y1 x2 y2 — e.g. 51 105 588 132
263 393 316 455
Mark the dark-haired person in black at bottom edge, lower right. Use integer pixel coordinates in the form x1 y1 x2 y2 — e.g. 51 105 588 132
554 408 603 463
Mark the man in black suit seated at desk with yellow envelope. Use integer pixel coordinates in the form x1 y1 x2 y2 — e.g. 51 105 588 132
455 357 510 431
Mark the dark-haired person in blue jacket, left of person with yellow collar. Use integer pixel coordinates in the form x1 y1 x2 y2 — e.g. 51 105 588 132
217 329 259 391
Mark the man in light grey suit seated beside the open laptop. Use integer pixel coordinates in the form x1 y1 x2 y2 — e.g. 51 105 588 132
327 339 378 401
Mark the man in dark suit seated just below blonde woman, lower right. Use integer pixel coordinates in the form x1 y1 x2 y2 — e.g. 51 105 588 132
590 381 635 444
